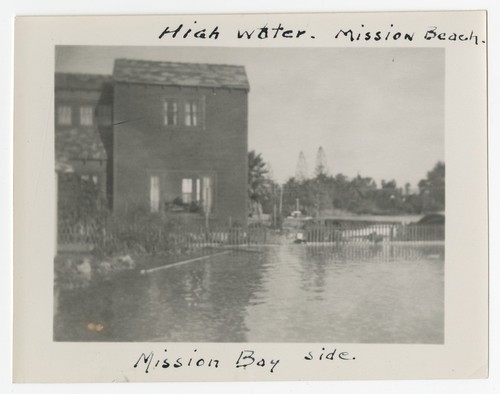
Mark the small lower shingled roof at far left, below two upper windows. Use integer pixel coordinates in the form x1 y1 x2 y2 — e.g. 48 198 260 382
55 128 107 162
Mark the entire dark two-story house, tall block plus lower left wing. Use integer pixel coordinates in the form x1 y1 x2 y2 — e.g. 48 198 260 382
55 59 249 225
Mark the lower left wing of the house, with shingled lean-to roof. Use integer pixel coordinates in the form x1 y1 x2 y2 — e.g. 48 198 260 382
54 73 113 215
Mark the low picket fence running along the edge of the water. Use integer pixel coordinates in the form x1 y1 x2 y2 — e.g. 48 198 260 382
58 221 445 253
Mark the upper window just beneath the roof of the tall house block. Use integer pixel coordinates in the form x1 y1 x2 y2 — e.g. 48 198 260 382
163 98 204 128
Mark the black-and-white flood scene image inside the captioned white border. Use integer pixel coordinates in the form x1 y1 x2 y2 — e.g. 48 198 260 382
53 45 446 344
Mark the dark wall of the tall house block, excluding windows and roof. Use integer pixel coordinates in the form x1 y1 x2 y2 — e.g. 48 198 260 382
113 83 248 225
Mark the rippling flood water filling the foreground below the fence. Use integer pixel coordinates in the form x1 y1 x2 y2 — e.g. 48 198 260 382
54 244 444 343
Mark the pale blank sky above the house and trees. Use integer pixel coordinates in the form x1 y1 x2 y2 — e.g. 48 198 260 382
56 46 445 187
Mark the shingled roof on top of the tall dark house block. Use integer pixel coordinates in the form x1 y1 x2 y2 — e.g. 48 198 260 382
113 59 249 90
